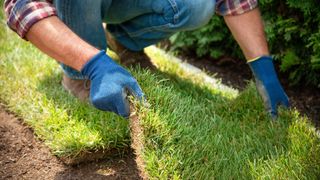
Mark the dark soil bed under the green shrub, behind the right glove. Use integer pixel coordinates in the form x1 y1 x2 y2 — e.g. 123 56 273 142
182 55 320 128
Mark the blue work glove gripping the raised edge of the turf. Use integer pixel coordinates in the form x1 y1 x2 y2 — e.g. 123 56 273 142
81 51 144 118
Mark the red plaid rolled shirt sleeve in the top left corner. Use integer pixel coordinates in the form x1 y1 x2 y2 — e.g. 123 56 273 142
4 0 56 38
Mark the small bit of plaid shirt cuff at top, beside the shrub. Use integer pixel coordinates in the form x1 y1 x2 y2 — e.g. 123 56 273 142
216 0 258 16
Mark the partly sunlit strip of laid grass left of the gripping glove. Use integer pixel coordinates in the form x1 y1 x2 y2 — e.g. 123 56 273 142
0 12 130 157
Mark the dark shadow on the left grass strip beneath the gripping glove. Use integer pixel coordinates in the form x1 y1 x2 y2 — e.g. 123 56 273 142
37 71 130 159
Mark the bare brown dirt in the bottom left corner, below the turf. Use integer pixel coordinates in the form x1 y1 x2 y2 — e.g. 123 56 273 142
0 106 141 180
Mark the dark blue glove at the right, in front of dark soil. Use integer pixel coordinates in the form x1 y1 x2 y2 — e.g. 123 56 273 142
248 56 289 119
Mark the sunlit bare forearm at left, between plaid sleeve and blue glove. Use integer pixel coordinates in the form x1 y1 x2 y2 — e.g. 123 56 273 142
26 16 99 70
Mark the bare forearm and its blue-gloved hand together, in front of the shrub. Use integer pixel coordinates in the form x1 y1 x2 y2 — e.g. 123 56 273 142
225 8 289 119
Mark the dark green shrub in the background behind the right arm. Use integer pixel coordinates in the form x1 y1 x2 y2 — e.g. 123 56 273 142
170 0 320 87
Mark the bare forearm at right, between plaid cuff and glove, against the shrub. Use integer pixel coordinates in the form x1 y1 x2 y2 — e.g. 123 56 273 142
224 8 269 60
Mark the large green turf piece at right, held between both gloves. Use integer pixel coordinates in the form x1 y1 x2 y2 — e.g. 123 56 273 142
141 49 320 179
